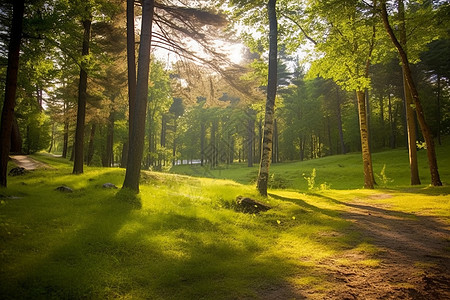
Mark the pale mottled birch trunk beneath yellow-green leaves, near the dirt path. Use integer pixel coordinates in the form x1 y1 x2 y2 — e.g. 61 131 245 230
356 91 375 189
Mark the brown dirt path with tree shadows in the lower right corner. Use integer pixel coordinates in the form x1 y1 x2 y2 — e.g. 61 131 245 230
311 195 450 300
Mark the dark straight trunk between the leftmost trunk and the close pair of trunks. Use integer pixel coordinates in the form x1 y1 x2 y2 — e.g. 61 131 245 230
72 19 91 174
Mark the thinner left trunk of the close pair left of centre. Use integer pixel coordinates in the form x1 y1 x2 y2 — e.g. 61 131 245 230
122 0 136 167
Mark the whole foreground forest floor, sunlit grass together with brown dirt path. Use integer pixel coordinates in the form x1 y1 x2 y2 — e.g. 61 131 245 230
0 155 450 300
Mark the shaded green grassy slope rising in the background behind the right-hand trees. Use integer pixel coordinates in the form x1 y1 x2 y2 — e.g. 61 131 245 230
171 141 450 190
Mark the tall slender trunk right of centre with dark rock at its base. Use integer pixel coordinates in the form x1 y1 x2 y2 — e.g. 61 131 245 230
257 0 278 196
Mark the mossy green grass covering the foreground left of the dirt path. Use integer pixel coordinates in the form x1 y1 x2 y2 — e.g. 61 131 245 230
0 150 450 299
